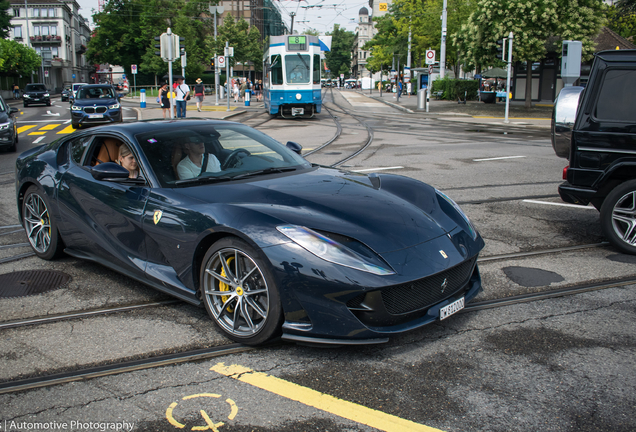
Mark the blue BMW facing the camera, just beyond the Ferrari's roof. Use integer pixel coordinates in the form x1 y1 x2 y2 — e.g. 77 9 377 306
71 84 123 129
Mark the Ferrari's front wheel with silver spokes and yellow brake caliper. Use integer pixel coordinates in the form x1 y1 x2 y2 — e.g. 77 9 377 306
199 237 283 345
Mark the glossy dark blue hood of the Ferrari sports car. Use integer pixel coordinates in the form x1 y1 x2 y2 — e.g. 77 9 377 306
181 168 457 253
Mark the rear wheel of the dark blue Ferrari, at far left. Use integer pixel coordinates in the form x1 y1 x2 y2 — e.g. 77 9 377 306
22 186 64 260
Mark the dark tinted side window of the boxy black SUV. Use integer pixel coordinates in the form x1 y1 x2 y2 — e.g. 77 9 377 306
594 69 636 122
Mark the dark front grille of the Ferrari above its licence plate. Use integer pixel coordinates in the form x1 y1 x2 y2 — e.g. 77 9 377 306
381 258 476 315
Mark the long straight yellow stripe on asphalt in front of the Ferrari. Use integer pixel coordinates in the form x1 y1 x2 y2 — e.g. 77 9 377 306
210 363 440 432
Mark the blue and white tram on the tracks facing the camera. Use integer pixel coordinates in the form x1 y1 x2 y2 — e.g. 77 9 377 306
263 35 322 118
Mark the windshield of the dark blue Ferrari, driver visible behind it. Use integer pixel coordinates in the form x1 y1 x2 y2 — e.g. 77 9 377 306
135 124 311 187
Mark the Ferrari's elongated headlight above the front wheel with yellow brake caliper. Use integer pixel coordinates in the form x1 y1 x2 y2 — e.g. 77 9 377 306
276 225 395 276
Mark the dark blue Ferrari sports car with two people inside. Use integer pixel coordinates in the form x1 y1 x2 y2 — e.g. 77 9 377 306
16 120 484 345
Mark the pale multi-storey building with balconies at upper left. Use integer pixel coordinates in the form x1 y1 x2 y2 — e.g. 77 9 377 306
9 0 93 93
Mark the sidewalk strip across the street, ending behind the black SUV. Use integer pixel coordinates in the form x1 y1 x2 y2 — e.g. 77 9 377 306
352 90 552 129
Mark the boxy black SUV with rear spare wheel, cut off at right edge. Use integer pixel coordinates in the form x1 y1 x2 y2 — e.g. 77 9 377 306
552 50 636 254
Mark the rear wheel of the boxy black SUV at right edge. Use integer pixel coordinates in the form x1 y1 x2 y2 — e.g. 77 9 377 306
601 180 636 255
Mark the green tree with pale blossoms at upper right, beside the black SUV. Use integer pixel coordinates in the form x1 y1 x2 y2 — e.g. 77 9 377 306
452 0 603 107
